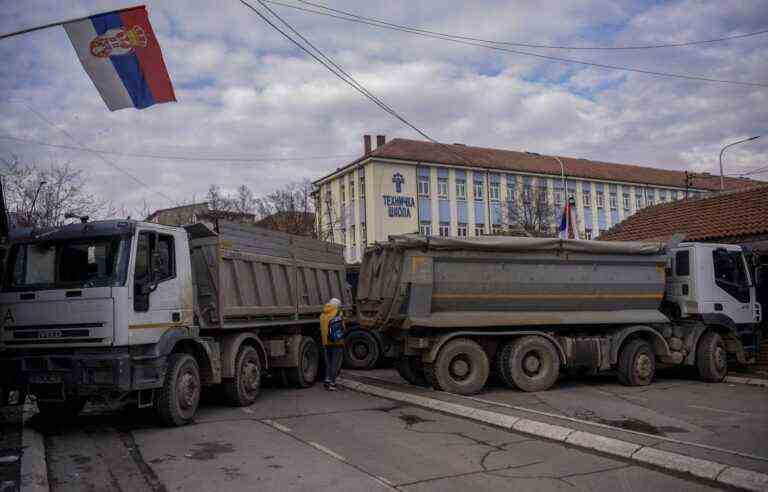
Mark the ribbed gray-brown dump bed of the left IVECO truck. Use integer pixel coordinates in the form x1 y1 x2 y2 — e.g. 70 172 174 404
188 221 351 328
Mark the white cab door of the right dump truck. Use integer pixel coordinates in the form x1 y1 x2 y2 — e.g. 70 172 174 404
711 248 755 325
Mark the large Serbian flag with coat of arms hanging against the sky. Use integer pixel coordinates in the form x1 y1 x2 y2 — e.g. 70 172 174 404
64 6 176 111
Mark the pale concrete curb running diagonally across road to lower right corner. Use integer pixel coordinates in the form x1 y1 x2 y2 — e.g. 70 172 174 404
336 378 768 492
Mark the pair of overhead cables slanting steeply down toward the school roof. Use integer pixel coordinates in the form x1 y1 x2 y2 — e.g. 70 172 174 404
238 0 480 168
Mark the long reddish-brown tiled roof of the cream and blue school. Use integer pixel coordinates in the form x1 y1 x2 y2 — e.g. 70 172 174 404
315 138 759 190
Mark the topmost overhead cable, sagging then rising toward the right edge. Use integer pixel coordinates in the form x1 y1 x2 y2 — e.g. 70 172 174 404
290 0 768 51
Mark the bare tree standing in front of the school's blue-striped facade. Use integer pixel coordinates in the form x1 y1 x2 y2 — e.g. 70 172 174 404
501 185 558 237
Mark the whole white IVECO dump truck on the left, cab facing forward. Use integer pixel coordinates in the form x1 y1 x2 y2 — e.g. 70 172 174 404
0 220 351 425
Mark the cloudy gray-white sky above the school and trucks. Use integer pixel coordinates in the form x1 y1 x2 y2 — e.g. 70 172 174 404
0 0 768 213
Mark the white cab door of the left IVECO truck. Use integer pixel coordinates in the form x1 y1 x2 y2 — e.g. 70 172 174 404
128 230 182 344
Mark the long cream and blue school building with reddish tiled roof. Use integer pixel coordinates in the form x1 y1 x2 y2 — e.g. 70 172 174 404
315 136 748 263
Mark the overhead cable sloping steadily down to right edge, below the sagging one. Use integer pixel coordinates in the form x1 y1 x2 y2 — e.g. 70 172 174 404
259 0 768 87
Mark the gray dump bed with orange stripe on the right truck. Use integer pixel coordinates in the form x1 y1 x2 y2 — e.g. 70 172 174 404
357 235 668 329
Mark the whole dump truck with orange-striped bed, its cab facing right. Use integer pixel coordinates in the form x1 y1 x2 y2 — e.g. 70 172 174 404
356 235 761 394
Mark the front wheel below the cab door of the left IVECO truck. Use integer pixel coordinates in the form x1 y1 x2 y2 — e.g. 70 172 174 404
155 354 200 427
